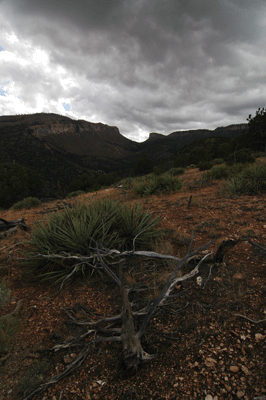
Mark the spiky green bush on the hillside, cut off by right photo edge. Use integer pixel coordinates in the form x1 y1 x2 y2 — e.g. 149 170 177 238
224 164 266 195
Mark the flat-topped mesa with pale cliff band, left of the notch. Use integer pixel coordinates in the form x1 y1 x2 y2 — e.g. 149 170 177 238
0 113 138 158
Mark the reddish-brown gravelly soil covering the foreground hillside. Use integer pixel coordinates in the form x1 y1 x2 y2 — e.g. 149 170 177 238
0 169 266 400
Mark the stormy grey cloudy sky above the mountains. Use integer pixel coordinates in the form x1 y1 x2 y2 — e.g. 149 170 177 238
0 0 266 141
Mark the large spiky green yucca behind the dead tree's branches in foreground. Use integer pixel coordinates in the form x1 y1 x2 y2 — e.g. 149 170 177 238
27 199 159 283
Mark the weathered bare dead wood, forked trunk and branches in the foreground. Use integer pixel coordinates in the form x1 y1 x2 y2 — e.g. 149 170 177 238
23 236 215 400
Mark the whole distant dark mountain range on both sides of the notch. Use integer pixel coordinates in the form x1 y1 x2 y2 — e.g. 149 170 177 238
0 113 247 185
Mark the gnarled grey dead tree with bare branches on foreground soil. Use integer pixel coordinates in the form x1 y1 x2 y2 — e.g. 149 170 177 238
21 236 213 400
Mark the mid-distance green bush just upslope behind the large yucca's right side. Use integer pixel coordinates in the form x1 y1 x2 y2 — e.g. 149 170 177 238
133 173 182 196
